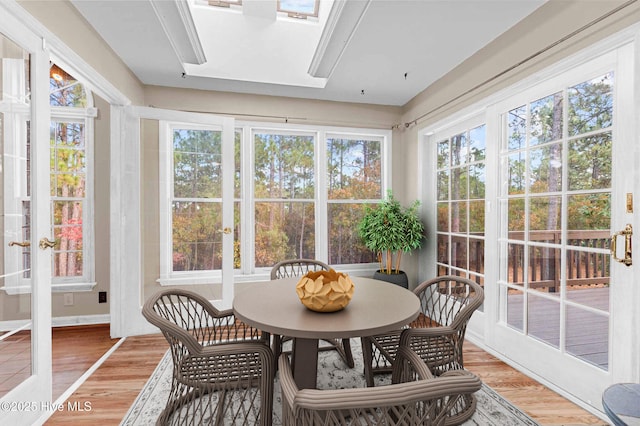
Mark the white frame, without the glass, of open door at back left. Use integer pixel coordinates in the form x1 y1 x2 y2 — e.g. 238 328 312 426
111 106 234 337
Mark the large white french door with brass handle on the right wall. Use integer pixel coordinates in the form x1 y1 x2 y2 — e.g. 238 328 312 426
486 45 639 410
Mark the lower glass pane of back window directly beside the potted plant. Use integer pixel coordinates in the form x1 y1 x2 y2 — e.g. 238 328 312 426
327 203 378 265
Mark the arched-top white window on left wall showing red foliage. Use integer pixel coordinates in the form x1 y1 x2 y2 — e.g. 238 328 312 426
49 64 95 288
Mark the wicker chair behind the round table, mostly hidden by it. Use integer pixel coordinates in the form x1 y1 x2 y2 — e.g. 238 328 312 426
271 259 355 368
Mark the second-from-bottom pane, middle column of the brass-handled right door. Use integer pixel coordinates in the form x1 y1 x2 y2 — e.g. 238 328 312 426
528 246 560 297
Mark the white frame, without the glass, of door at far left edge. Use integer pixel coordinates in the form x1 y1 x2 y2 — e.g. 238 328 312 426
0 4 52 424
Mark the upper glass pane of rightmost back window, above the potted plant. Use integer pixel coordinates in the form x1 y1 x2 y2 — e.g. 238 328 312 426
327 138 382 200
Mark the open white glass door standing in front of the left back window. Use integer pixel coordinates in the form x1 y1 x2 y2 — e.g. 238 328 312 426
111 107 238 336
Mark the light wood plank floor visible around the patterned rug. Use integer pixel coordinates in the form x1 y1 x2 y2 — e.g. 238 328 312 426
46 326 607 426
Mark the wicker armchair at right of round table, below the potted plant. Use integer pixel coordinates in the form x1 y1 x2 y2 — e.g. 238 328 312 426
361 275 484 386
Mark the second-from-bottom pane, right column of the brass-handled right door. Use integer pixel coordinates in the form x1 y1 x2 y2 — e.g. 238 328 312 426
567 250 611 312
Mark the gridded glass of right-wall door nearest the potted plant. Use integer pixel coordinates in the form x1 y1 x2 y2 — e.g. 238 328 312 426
436 124 486 292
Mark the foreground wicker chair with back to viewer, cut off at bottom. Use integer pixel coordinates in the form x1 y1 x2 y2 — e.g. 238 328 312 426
278 347 482 426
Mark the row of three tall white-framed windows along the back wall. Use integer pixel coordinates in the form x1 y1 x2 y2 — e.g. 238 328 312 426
160 123 391 285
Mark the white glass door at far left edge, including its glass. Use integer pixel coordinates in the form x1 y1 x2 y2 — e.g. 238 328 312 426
0 25 52 424
